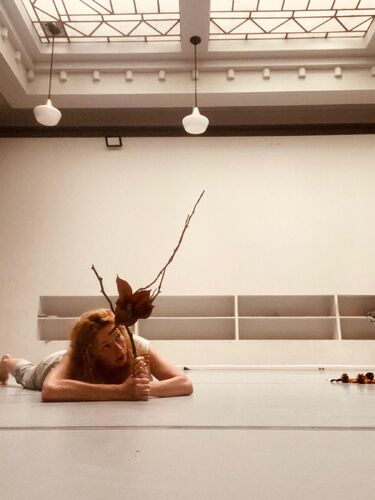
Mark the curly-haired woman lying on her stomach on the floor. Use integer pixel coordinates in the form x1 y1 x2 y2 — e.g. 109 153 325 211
0 309 193 401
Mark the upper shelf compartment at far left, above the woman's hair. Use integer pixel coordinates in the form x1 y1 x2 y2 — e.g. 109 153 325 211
39 295 118 318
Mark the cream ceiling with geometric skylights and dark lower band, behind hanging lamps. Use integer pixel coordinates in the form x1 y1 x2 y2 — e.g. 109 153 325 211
0 0 375 135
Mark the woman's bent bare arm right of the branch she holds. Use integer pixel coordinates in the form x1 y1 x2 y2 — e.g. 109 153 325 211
149 349 193 397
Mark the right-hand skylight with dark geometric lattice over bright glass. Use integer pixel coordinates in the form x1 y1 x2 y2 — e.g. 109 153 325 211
210 0 375 40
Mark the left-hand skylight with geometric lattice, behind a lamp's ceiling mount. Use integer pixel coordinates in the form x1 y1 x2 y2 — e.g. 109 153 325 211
22 0 180 43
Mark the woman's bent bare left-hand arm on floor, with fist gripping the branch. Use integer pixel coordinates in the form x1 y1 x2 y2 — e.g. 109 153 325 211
42 353 150 402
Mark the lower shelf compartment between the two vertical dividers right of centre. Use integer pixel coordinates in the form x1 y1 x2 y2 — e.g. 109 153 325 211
239 317 338 340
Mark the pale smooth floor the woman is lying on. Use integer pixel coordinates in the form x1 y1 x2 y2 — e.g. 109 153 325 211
0 370 375 500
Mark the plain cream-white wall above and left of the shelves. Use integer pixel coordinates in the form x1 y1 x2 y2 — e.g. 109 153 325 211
0 135 375 358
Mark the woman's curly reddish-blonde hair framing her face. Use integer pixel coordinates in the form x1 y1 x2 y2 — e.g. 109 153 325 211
70 309 131 384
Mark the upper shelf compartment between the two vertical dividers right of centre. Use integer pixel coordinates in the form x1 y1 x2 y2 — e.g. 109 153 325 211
238 295 336 317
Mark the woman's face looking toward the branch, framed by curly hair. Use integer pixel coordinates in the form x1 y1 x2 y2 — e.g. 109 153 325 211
93 323 128 368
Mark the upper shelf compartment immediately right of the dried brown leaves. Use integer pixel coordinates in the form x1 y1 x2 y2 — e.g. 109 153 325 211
152 295 234 317
